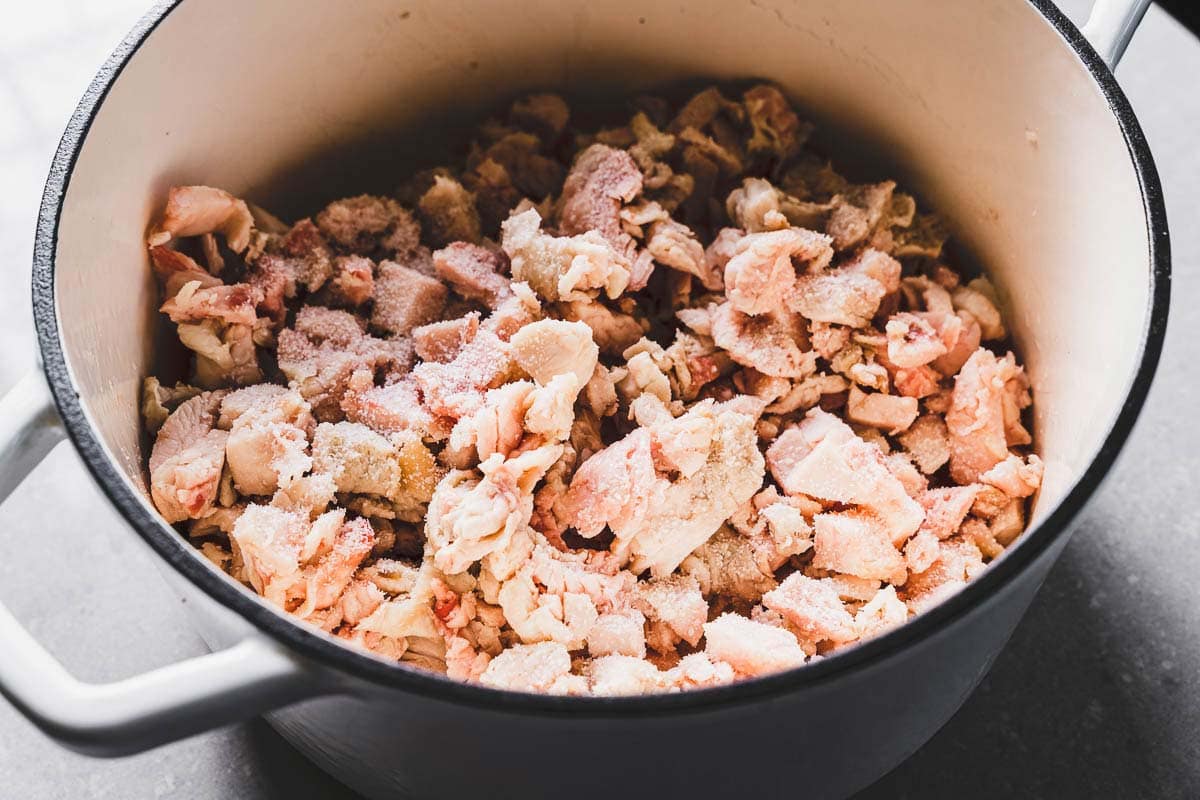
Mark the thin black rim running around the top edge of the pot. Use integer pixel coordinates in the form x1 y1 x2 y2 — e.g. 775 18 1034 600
32 0 1171 717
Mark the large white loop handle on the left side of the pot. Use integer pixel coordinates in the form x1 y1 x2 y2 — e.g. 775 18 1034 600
0 372 330 756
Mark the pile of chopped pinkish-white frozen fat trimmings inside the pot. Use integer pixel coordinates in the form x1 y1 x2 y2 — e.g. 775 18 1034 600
143 85 1042 694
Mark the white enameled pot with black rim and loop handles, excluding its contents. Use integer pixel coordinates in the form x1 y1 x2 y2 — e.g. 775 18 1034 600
0 0 1169 798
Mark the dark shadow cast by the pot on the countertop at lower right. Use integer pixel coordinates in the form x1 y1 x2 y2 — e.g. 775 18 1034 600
857 523 1200 800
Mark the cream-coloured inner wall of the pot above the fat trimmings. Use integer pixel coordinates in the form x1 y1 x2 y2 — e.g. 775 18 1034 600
55 0 1150 556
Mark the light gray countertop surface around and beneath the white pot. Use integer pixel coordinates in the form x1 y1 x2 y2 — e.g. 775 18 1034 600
0 0 1200 800
